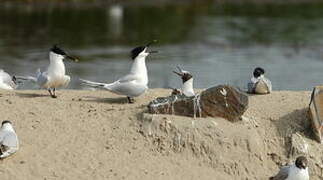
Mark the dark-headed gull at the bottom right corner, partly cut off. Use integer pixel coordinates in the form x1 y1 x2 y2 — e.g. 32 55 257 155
269 156 310 180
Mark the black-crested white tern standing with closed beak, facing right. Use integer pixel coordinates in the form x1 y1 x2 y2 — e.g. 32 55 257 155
16 45 78 98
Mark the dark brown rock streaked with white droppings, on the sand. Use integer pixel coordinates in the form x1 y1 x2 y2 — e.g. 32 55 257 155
148 85 248 121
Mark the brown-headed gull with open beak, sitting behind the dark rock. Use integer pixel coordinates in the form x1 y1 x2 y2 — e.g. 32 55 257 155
173 66 195 97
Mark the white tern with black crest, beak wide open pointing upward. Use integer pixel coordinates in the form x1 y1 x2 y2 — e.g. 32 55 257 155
80 40 157 103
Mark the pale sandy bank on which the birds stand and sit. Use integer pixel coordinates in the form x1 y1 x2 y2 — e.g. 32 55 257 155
0 89 323 180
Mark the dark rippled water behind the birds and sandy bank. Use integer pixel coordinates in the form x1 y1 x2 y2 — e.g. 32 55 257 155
0 2 323 90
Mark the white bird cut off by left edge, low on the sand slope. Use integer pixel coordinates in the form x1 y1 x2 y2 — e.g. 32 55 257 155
0 121 19 159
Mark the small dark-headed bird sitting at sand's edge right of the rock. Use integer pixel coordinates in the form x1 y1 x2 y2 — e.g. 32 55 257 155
248 67 272 94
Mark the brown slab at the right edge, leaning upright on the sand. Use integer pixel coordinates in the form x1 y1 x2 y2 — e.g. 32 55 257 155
309 86 323 143
